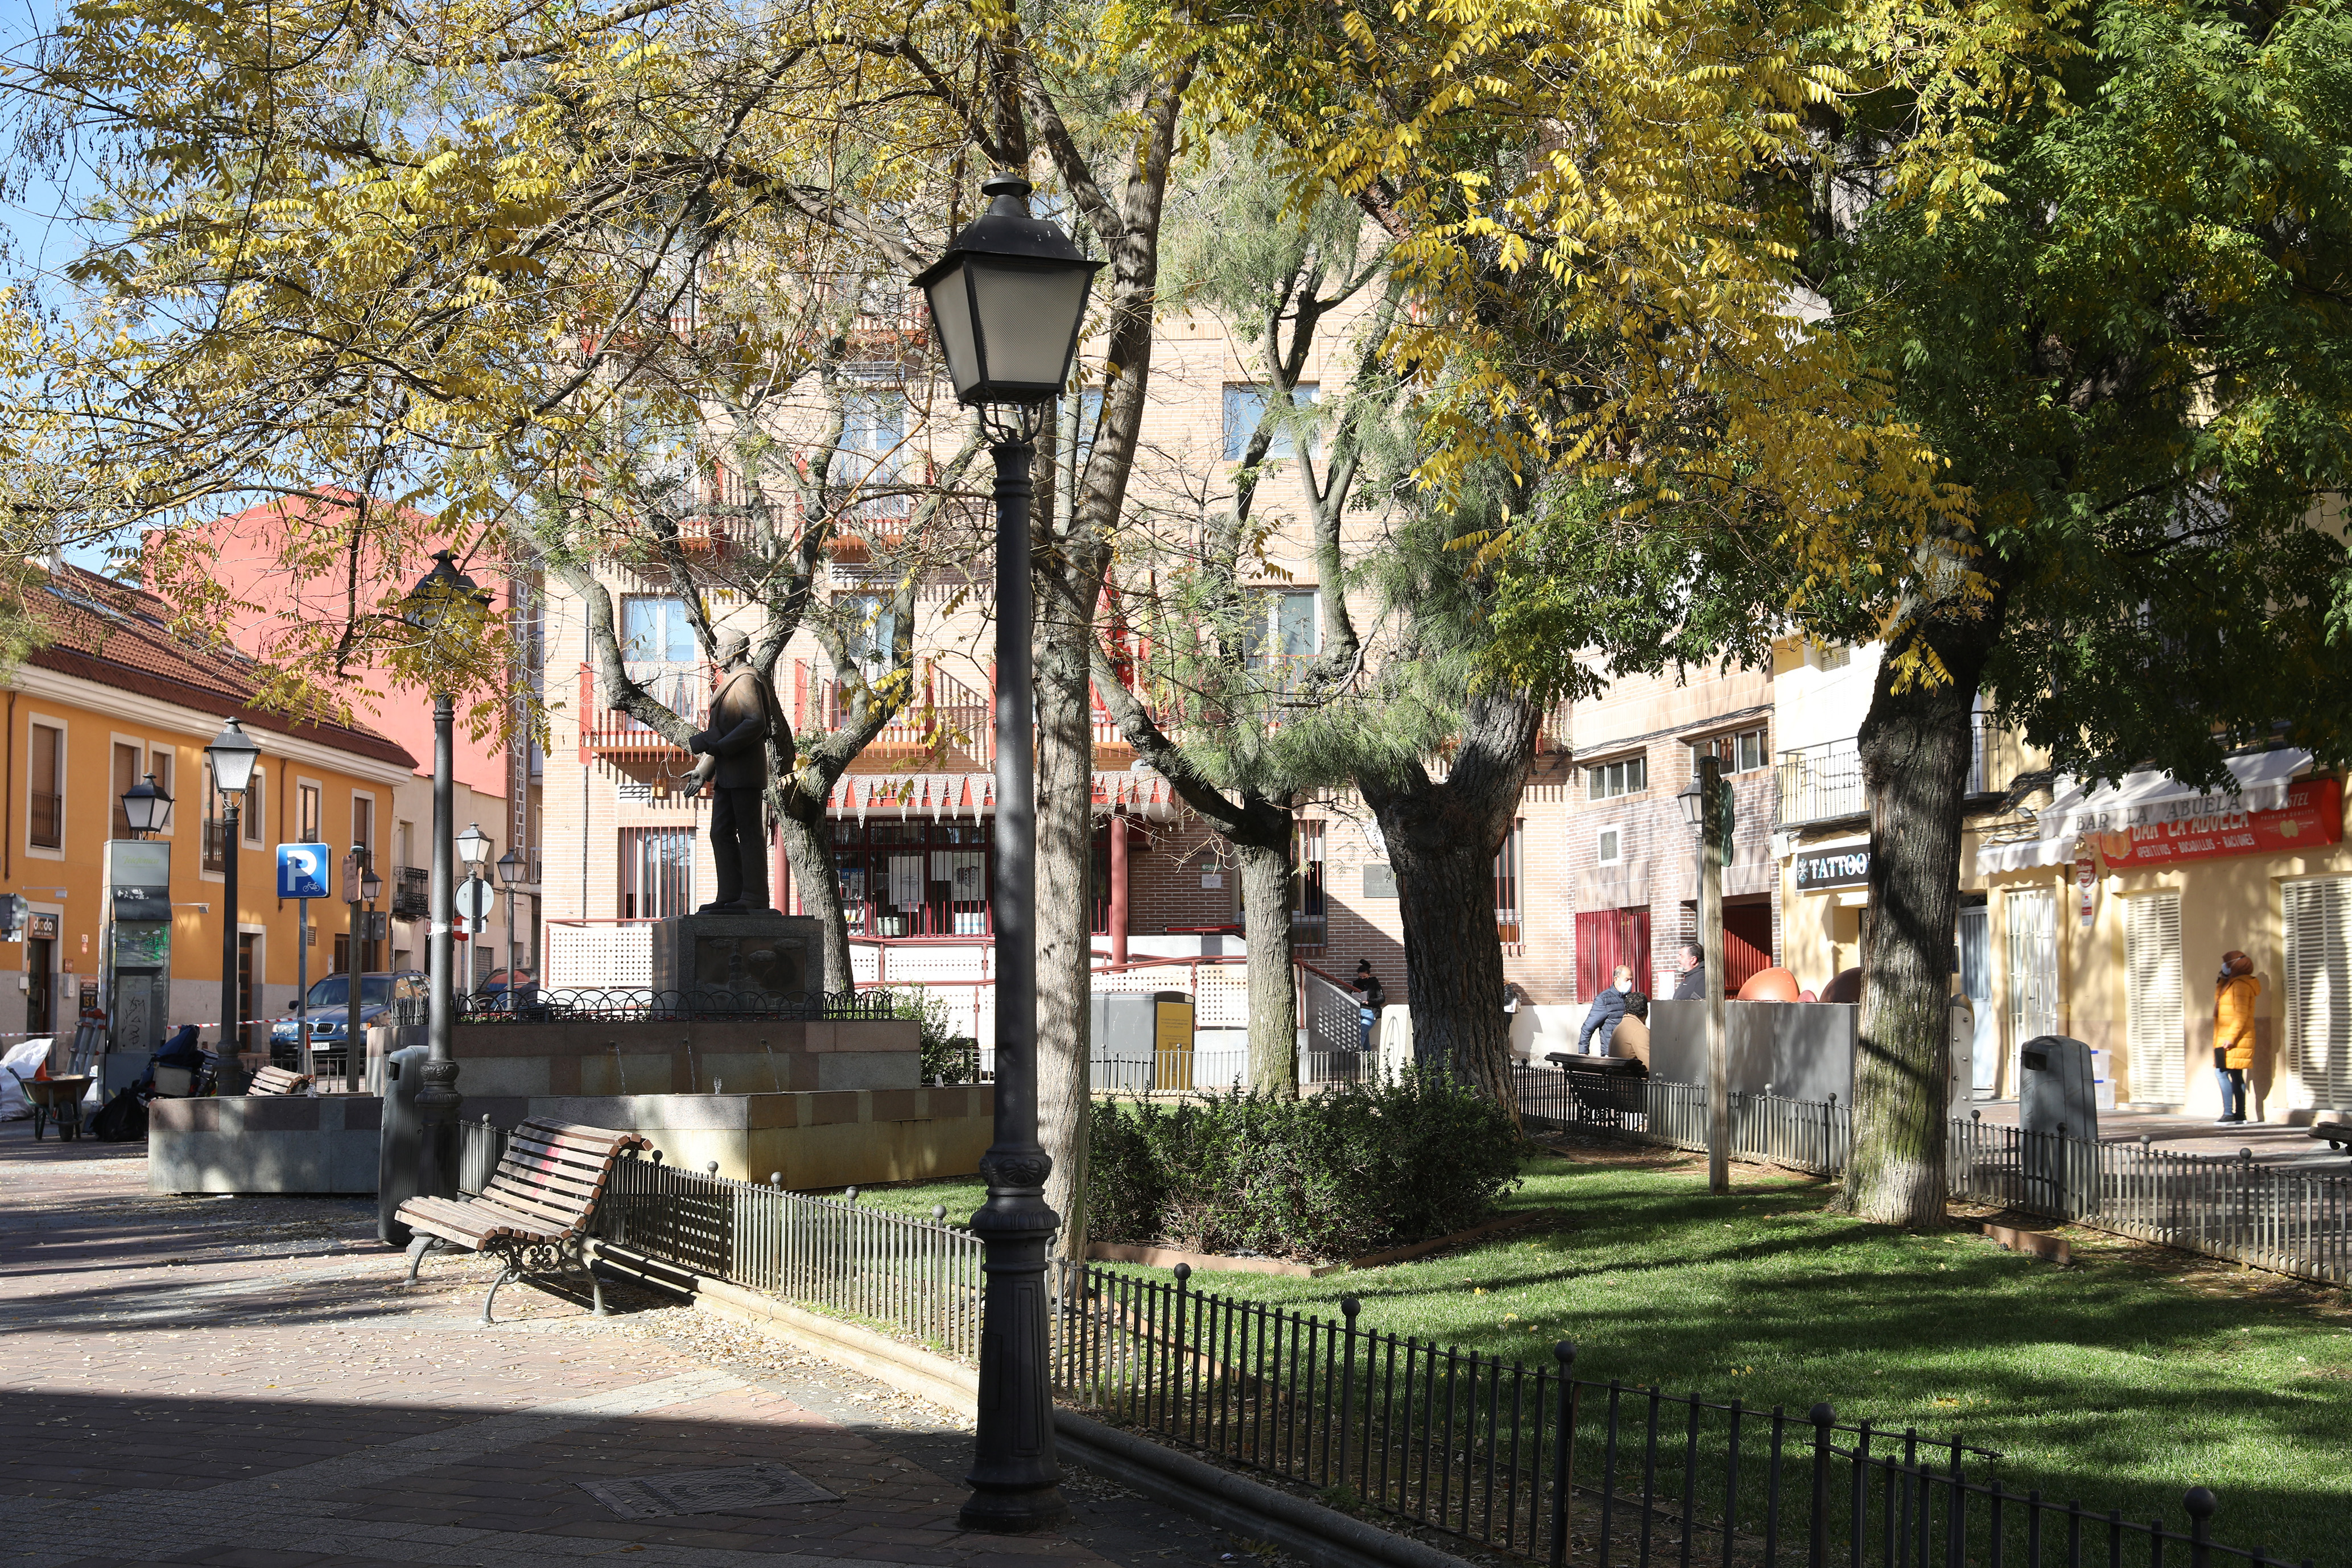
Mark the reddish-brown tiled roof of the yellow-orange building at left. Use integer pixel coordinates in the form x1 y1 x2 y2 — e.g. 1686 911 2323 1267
23 567 416 769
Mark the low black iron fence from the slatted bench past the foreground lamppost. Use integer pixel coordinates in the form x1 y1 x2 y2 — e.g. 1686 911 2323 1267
588 1159 2270 1568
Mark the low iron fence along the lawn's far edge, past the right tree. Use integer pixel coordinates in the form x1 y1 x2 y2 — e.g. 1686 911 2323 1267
1520 1065 2352 1284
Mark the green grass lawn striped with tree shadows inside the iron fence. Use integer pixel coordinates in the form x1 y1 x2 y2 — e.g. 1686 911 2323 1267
837 1150 2352 1563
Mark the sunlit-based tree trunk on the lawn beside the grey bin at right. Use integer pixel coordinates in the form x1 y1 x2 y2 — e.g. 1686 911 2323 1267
1842 606 1999 1227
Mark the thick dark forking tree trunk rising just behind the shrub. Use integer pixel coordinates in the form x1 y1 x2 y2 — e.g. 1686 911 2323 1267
1357 691 1543 1121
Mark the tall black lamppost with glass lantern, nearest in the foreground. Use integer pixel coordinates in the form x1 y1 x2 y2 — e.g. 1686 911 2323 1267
915 172 1101 1530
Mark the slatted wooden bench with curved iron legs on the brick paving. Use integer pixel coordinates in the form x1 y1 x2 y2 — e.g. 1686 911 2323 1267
393 1121 654 1323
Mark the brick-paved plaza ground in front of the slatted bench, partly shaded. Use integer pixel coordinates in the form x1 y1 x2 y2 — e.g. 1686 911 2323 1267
0 1121 1244 1568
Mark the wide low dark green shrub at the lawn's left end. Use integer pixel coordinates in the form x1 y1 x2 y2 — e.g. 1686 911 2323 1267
1087 1072 1520 1260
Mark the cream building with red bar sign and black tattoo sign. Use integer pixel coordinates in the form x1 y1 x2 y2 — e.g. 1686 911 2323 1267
1773 639 2352 1121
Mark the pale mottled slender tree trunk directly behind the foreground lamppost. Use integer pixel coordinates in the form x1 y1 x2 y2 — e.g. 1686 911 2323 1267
1035 564 1101 1260
